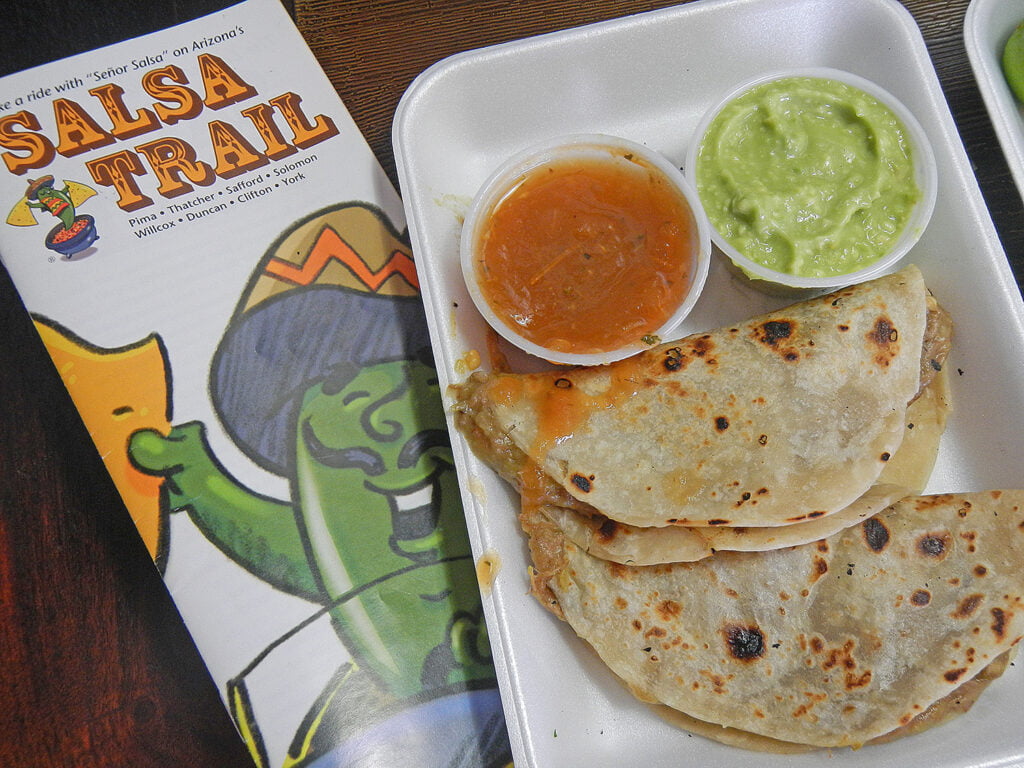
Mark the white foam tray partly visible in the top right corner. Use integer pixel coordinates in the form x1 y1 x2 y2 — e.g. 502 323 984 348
964 0 1024 202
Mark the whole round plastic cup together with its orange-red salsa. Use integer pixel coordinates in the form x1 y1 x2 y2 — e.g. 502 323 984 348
460 134 711 365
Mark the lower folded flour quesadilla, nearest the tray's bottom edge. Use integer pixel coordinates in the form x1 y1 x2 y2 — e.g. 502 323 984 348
523 490 1024 749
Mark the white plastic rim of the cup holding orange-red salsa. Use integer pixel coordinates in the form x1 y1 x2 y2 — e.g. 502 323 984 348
460 133 711 366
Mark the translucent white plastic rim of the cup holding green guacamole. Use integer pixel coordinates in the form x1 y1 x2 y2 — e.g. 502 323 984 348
686 67 938 290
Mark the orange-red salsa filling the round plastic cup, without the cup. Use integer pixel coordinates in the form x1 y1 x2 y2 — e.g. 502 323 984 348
475 153 697 354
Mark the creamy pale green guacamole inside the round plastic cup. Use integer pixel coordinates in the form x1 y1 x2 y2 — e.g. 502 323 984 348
695 77 921 278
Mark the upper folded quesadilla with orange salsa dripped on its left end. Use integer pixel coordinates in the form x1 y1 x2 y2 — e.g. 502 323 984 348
455 266 940 527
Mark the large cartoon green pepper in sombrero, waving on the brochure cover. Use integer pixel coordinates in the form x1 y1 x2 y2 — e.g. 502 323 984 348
130 204 511 768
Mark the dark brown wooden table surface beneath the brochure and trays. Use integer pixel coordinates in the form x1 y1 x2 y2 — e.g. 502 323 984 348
0 0 1024 768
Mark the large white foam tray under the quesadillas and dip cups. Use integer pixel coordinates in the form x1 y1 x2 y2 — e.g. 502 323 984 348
393 0 1024 768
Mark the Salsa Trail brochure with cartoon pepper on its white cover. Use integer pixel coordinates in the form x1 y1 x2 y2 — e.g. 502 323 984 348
0 0 511 768
